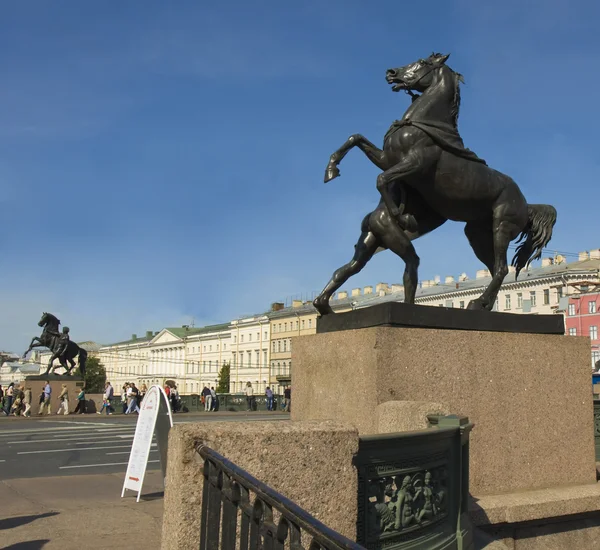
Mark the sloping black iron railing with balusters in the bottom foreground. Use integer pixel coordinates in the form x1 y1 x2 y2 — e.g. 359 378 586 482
196 445 364 550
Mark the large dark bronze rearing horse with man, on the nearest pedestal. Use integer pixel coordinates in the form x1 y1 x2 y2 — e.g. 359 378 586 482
313 54 556 315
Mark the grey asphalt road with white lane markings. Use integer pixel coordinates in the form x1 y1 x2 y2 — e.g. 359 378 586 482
0 413 289 479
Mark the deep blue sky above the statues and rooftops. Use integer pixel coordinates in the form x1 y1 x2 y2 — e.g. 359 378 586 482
0 0 600 351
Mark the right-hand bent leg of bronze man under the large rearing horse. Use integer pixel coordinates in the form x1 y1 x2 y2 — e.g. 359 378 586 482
369 210 420 304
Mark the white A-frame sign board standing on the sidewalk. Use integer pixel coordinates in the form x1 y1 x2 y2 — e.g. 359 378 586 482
121 386 173 502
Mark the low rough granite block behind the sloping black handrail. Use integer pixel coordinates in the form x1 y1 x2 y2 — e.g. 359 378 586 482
162 421 358 550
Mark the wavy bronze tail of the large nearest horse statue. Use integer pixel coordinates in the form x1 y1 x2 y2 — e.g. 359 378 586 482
512 204 556 278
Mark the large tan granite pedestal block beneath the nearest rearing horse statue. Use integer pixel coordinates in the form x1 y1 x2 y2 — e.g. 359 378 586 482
292 327 596 496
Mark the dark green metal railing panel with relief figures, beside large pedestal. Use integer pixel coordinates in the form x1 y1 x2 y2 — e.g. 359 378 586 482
355 417 472 550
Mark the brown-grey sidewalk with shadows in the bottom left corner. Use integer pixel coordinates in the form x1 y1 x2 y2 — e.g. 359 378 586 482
0 471 163 550
